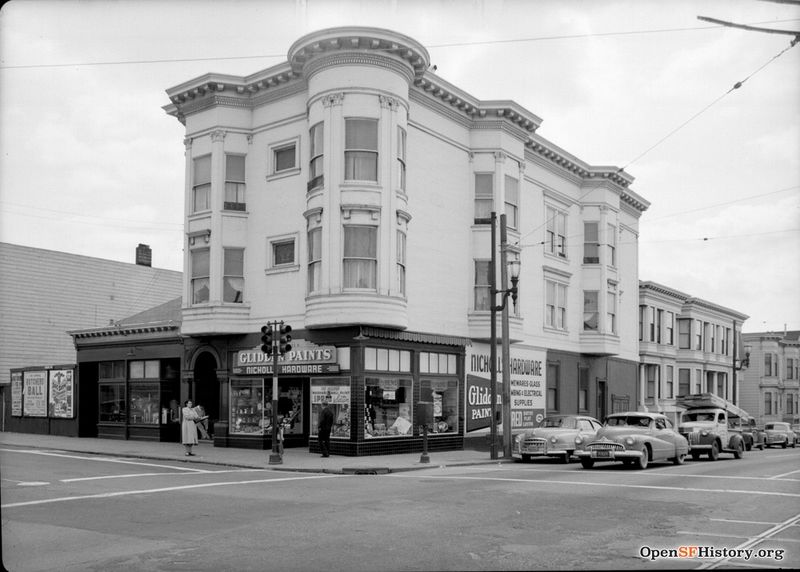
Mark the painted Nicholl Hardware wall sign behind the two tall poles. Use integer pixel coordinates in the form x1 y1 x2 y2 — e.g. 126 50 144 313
466 344 546 432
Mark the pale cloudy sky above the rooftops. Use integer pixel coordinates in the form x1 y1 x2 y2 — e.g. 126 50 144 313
0 0 800 332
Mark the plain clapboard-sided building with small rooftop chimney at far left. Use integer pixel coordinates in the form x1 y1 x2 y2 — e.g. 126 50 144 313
0 243 182 433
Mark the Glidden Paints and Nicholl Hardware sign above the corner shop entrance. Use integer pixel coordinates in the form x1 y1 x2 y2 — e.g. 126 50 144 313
233 339 339 376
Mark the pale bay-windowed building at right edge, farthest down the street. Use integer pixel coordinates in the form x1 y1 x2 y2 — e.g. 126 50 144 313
739 330 800 424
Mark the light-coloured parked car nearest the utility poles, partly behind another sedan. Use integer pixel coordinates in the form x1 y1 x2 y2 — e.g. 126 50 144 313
513 415 603 463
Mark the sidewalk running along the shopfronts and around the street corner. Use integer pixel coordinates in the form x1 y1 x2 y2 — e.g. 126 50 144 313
0 432 513 474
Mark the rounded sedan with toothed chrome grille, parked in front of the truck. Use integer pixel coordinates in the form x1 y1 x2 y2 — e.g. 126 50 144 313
575 411 689 469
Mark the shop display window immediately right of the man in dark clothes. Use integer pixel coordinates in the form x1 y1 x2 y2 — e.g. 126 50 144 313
364 376 414 439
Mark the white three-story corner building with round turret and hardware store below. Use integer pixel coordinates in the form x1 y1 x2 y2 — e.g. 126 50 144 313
165 28 649 455
